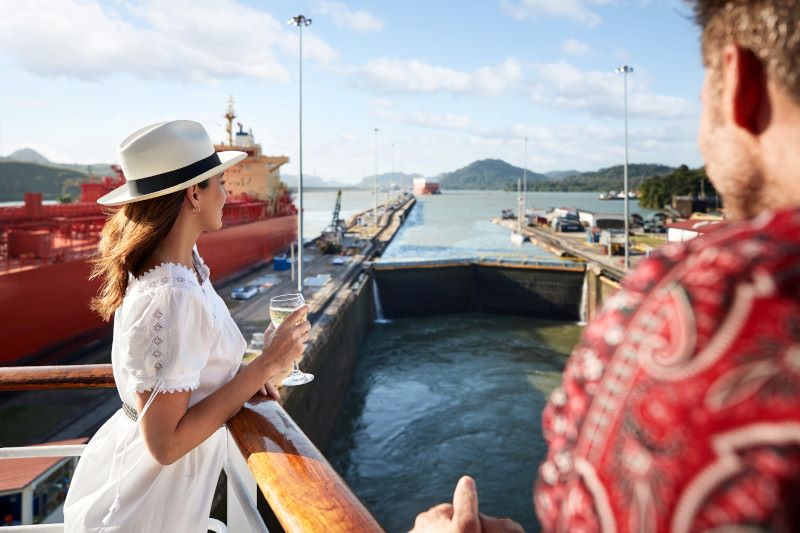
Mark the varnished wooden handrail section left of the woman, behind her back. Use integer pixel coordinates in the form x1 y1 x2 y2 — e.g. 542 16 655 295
0 364 115 391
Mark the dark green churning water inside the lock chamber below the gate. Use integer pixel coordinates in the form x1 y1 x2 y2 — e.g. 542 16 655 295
326 314 581 533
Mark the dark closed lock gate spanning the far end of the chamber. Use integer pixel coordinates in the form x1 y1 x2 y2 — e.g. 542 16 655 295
375 264 584 320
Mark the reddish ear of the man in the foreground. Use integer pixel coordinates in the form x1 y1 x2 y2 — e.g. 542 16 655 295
722 44 771 135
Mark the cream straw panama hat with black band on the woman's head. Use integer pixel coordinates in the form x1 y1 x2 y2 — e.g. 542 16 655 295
97 120 247 206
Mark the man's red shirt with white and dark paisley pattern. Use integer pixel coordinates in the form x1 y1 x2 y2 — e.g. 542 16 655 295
534 210 800 532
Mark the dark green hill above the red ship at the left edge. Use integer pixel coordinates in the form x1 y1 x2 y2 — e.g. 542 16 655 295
0 160 86 202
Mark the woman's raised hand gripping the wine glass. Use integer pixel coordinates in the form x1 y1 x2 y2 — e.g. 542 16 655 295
253 305 311 384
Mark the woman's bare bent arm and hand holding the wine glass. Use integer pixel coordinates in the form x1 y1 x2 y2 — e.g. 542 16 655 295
136 306 311 465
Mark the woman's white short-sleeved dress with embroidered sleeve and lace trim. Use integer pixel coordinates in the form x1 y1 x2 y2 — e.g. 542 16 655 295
64 251 246 533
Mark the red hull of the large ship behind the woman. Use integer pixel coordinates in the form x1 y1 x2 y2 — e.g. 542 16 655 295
0 215 297 366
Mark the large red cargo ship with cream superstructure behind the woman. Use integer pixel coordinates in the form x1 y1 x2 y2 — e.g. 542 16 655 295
0 102 297 366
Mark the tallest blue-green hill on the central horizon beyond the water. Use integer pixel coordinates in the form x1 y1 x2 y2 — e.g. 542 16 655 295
437 159 547 191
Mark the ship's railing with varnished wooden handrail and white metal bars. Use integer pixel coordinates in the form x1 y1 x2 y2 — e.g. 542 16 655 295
0 364 383 533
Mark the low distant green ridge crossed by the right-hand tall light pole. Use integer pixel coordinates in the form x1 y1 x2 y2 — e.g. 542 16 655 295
528 163 675 192
